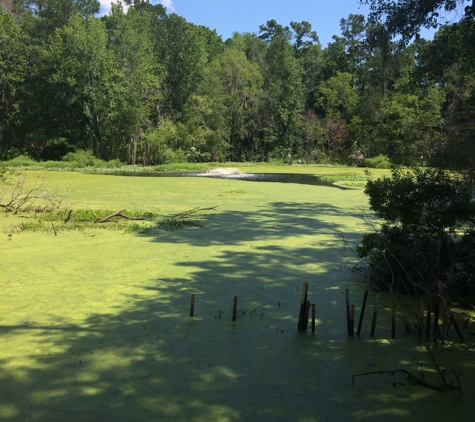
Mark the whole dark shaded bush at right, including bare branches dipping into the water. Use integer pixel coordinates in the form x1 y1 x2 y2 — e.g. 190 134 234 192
346 169 475 392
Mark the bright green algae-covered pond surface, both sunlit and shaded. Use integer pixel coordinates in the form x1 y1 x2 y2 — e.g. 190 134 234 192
0 173 475 421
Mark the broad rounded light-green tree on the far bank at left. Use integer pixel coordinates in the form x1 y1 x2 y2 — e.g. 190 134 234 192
38 16 121 158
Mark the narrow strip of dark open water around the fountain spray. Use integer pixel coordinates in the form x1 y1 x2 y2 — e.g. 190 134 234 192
104 172 352 190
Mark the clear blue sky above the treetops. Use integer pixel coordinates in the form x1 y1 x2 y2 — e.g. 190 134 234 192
100 0 448 47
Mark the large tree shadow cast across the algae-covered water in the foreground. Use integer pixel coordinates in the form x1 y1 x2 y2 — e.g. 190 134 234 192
0 203 468 421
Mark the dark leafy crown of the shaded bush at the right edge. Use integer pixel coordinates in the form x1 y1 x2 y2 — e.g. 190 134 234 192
358 169 475 292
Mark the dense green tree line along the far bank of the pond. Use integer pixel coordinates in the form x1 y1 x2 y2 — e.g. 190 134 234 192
0 0 475 167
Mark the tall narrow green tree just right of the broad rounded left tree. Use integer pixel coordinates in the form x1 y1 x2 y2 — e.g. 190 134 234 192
102 3 165 164
